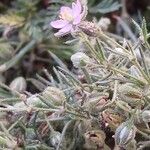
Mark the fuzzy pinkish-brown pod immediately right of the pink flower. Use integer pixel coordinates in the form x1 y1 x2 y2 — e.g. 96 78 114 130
78 21 101 37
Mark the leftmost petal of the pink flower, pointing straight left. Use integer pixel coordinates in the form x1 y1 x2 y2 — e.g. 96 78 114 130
50 19 68 29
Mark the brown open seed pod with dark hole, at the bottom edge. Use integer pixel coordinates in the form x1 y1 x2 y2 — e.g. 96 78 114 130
84 130 106 150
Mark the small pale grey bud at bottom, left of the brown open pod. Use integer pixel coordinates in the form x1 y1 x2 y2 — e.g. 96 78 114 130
50 131 61 147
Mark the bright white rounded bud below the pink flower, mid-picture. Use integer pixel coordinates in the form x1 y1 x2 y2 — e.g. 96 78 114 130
71 52 90 68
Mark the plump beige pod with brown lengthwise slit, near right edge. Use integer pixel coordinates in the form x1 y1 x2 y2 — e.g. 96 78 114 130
118 83 144 107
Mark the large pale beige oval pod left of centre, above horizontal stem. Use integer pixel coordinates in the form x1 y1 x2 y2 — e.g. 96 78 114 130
42 86 66 106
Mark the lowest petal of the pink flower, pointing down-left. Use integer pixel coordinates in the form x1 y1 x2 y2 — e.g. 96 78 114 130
54 24 73 37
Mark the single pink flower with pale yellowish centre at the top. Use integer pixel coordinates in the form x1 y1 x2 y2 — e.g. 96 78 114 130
50 0 83 37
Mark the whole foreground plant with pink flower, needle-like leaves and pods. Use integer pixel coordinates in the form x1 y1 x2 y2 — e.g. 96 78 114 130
0 0 150 150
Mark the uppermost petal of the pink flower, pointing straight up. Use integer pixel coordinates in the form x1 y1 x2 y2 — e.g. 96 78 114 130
72 0 82 17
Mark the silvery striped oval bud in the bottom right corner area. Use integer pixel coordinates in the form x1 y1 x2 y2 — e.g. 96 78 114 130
115 121 136 147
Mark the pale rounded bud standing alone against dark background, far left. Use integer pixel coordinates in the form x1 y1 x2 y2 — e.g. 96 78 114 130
9 77 27 93
